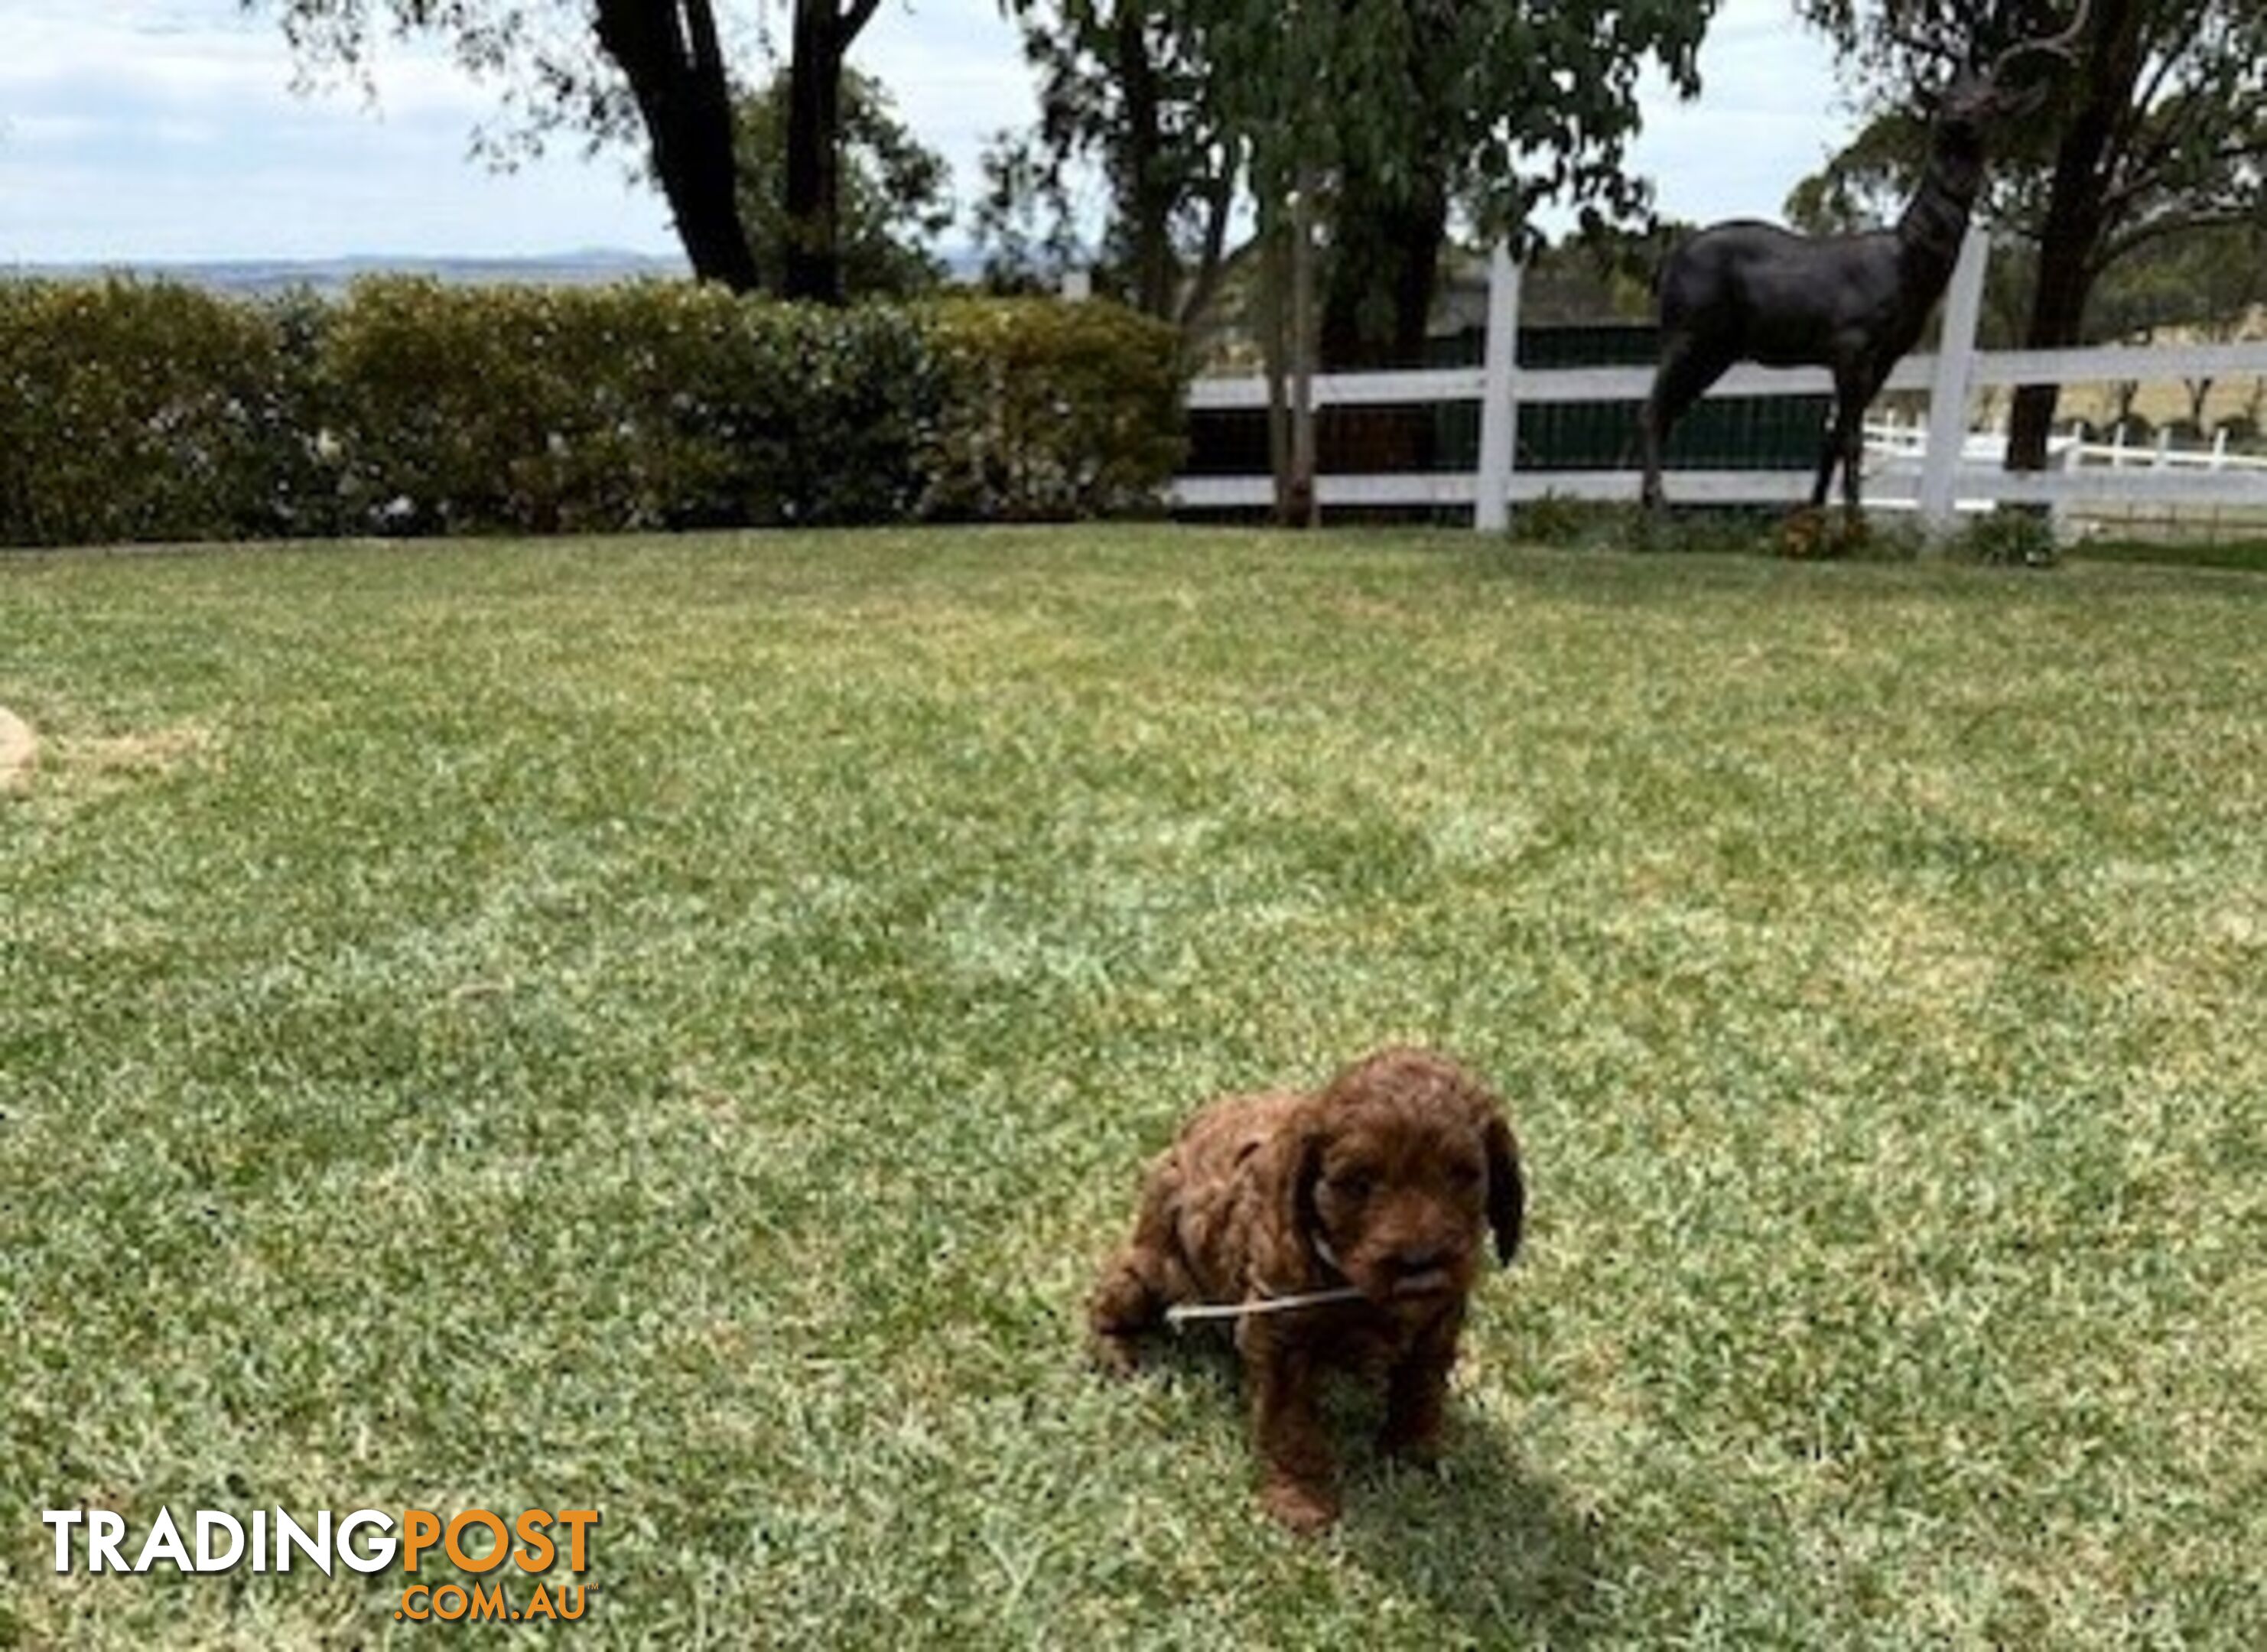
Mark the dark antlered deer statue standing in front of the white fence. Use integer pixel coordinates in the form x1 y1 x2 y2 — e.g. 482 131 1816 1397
1639 0 2086 515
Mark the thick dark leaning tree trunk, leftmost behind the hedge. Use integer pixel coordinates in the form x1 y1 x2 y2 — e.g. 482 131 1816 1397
597 0 757 292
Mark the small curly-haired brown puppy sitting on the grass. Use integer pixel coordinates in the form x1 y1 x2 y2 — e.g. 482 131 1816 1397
1088 1049 1526 1532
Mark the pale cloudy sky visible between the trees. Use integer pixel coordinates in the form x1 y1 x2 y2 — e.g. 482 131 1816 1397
0 0 1850 265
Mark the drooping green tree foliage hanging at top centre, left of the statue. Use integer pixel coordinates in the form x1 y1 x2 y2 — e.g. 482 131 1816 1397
1004 0 1716 356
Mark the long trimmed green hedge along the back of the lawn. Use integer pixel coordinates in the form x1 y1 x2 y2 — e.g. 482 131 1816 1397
0 276 1183 544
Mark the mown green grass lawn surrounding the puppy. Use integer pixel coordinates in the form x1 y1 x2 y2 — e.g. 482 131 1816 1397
0 528 2267 1652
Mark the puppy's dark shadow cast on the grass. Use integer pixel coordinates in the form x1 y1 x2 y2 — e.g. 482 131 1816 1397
1124 1332 1605 1645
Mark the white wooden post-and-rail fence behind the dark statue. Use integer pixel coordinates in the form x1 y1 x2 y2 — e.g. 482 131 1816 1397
1172 229 2267 530
